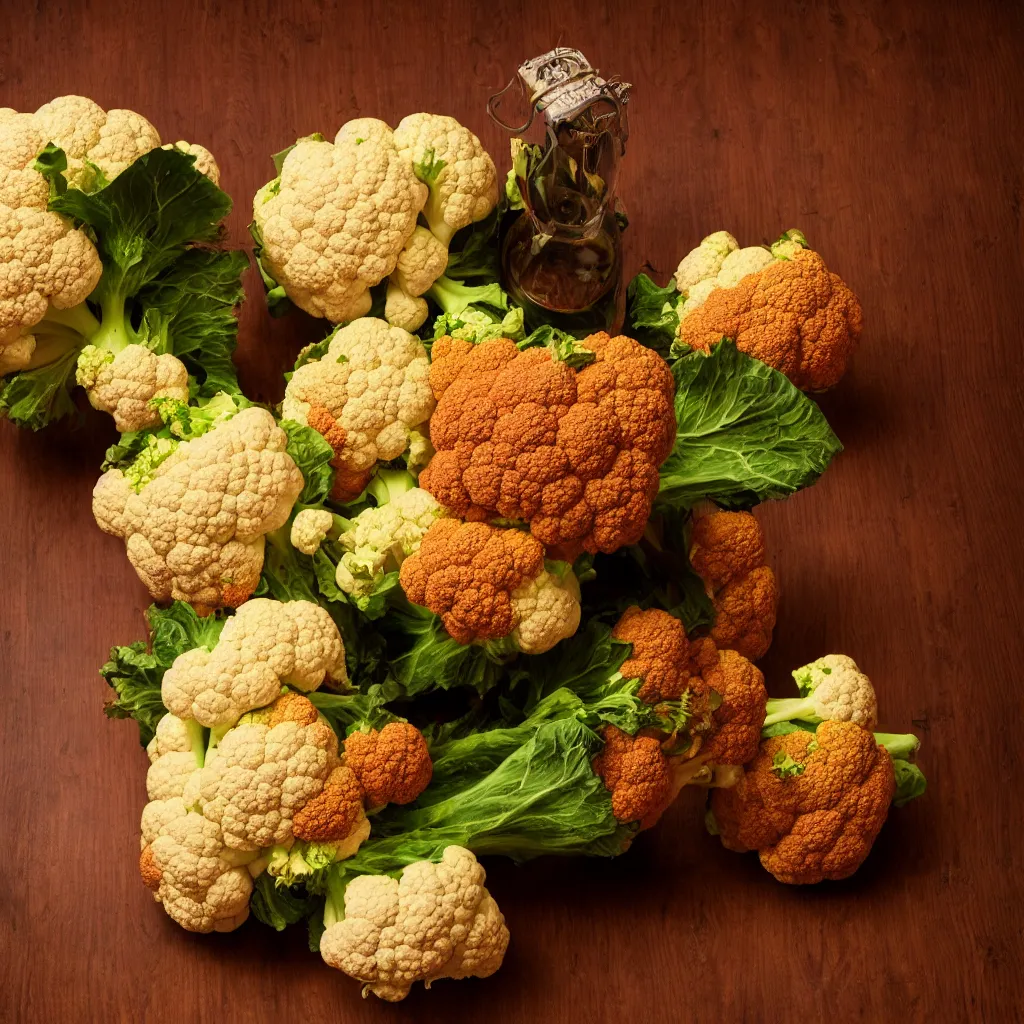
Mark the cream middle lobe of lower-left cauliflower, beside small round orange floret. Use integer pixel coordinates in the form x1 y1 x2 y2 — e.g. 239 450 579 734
197 721 338 850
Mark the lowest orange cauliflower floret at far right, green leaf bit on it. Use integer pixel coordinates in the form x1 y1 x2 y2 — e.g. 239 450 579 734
709 722 896 885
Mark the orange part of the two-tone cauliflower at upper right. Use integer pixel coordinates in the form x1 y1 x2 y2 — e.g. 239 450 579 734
679 246 862 391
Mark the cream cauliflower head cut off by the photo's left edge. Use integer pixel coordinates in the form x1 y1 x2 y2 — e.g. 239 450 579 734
0 109 103 376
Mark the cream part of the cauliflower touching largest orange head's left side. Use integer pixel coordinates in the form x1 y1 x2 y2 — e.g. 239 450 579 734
282 316 434 473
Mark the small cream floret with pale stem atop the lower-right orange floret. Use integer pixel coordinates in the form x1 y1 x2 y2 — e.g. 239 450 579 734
764 654 879 729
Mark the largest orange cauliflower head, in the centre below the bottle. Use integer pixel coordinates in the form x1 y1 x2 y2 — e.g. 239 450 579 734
420 334 676 561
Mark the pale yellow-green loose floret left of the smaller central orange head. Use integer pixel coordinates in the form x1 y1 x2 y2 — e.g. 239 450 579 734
335 487 444 595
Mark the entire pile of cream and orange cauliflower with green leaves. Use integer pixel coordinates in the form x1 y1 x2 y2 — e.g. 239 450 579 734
0 96 925 1000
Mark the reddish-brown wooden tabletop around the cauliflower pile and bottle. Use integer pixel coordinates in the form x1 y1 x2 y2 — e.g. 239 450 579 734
0 0 1024 1024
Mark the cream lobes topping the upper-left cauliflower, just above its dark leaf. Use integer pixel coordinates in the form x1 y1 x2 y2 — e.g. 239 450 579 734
35 95 160 189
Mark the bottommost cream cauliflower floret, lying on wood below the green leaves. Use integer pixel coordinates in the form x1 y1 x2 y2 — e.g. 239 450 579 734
321 846 509 1002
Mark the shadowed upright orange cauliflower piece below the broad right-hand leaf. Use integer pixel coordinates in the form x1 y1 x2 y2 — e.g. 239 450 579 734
690 508 778 662
